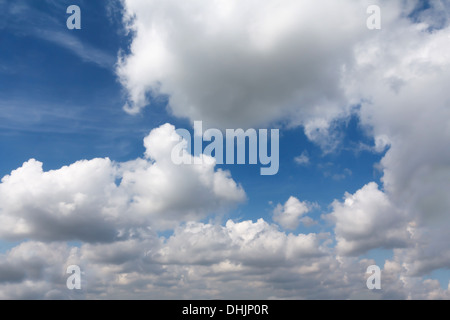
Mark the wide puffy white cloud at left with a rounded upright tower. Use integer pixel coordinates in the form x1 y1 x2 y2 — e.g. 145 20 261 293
0 124 245 242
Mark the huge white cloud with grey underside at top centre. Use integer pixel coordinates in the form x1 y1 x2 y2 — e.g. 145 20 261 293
117 0 376 128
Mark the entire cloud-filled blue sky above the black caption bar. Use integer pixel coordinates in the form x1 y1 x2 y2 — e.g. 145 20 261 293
0 0 450 299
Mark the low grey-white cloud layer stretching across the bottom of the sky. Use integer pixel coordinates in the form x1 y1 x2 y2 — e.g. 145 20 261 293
0 220 449 299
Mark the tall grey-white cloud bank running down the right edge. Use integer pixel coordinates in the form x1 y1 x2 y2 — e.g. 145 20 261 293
336 1 450 275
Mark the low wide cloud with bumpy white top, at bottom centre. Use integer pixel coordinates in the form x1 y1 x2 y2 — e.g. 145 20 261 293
156 219 325 268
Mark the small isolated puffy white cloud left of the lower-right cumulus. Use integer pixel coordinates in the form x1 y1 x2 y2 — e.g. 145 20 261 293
273 197 311 230
